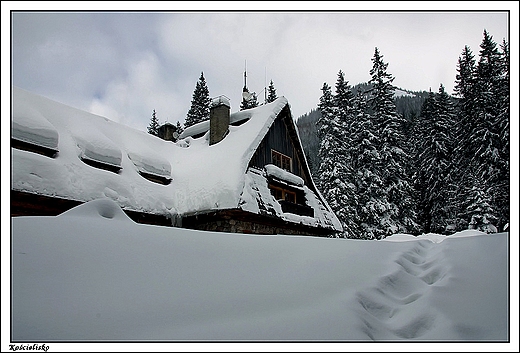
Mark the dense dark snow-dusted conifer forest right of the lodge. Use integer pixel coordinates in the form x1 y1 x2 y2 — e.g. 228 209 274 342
297 30 510 239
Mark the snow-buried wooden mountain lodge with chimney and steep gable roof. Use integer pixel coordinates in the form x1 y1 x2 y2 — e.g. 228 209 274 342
11 87 341 236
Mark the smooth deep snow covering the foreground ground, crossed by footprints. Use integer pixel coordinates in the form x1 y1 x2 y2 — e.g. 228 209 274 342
4 199 518 351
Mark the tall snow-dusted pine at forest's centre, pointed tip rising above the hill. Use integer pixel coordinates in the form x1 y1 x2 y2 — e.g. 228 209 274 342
368 48 417 236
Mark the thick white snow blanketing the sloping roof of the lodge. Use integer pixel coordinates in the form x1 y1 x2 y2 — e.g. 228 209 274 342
11 87 341 229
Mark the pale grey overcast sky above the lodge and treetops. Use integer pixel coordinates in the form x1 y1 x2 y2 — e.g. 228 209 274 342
5 2 509 130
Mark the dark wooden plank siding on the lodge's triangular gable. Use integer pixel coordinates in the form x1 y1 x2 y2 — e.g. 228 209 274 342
249 106 316 191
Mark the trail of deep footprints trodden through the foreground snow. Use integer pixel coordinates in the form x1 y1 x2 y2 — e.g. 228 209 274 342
356 240 449 340
